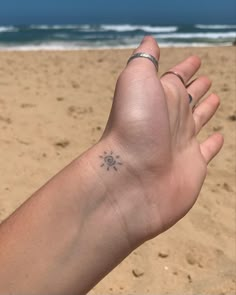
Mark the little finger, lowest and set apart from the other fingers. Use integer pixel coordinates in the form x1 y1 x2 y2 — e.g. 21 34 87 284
200 133 224 164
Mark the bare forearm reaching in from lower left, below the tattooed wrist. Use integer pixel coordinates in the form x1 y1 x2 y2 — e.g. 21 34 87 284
0 143 136 294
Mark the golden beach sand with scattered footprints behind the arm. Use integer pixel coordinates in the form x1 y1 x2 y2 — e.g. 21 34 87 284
0 47 236 295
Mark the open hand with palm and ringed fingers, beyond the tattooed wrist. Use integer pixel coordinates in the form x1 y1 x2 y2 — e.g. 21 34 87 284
101 37 223 245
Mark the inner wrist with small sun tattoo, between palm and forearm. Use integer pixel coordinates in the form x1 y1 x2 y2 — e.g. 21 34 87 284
77 138 157 252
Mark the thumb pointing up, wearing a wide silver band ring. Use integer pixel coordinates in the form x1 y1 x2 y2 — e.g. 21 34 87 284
109 36 166 128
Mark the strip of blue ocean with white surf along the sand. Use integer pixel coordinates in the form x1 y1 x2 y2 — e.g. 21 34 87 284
0 24 236 50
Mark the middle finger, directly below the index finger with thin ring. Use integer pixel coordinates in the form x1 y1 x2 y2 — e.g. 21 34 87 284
187 76 211 106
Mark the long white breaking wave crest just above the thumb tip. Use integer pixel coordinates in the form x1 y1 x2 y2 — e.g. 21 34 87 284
101 24 178 33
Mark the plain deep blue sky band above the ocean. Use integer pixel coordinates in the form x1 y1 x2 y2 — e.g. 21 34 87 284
0 0 236 25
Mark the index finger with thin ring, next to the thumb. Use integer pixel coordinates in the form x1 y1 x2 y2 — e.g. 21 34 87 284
162 56 201 87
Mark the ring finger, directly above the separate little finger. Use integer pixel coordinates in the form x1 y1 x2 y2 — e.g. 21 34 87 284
193 94 220 134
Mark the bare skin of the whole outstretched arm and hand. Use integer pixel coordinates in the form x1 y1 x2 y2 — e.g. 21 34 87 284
0 37 223 295
